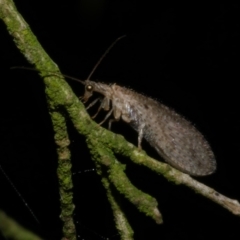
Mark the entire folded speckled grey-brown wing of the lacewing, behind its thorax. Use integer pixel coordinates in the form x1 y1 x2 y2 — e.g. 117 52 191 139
113 86 216 176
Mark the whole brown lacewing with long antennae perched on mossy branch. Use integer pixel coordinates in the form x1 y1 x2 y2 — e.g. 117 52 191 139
12 36 216 176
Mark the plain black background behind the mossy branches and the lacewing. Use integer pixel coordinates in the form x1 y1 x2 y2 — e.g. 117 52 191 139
0 0 240 240
